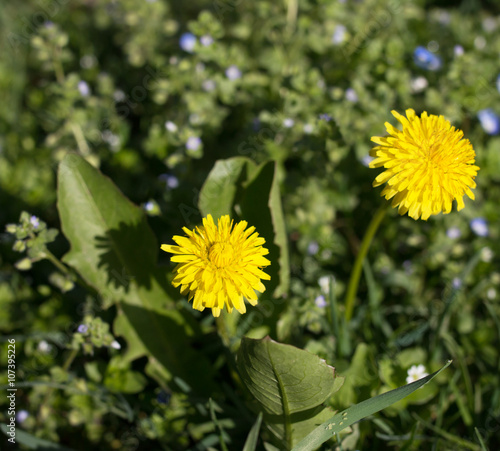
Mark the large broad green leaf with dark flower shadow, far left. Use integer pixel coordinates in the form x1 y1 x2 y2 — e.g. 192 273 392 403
58 154 212 392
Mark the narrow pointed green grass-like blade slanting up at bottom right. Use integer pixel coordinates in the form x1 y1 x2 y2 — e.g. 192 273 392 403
292 360 451 451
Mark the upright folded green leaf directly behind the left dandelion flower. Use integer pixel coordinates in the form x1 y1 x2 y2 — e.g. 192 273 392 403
198 157 290 297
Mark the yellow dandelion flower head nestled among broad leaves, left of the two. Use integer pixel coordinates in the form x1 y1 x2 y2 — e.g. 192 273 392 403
161 215 271 317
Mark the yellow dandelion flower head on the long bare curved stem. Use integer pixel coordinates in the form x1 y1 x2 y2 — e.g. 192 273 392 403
370 109 479 220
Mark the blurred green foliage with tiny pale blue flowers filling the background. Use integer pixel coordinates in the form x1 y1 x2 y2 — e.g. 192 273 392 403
0 0 500 450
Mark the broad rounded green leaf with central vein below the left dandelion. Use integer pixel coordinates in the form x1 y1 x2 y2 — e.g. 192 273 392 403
236 337 335 449
